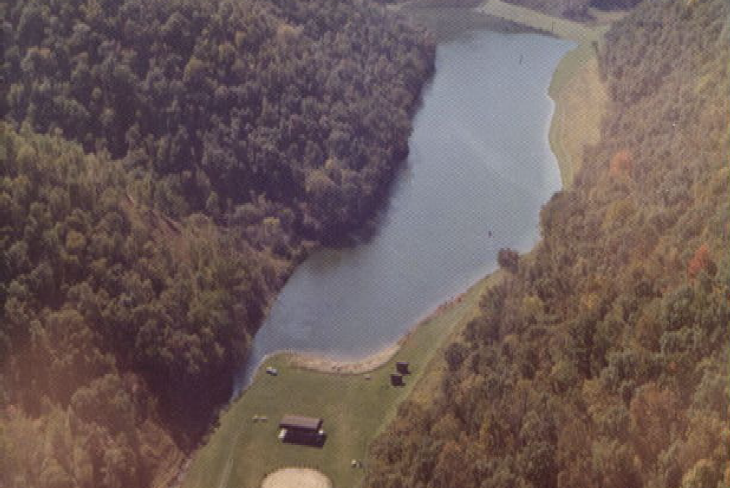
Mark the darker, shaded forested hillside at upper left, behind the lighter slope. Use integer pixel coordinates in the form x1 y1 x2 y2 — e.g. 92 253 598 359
4 0 433 242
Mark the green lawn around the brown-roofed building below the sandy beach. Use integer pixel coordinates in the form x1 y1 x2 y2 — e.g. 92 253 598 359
183 273 500 488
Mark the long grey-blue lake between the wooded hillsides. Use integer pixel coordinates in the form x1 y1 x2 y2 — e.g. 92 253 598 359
234 31 573 395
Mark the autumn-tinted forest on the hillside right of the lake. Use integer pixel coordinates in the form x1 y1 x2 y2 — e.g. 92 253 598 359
368 0 730 488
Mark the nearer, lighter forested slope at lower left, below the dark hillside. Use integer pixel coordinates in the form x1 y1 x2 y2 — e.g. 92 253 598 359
0 126 277 487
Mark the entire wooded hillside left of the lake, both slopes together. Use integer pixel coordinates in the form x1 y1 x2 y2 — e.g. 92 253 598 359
0 0 434 488
